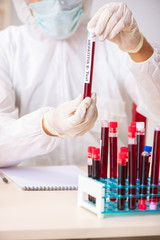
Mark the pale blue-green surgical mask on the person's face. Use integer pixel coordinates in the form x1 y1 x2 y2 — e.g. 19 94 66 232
30 0 83 40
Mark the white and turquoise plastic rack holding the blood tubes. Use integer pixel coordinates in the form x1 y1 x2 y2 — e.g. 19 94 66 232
78 175 160 218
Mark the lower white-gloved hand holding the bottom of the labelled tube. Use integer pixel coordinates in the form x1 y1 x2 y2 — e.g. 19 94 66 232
43 93 98 137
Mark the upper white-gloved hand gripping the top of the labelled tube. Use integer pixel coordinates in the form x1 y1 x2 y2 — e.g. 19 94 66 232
88 2 143 53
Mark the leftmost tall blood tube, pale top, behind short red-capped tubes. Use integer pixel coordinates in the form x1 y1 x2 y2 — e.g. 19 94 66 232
100 120 109 178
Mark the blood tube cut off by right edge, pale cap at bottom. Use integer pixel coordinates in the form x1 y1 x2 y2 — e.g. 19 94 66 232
149 125 160 210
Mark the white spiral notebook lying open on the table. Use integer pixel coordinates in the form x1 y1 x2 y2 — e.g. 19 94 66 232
0 165 86 191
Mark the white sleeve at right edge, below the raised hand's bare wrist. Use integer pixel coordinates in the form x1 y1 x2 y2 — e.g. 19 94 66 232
125 45 160 122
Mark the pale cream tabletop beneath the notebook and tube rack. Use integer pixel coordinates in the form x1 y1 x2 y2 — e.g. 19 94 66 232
0 167 160 240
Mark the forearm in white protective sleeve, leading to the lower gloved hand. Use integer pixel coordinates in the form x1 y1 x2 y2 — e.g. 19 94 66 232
0 81 60 167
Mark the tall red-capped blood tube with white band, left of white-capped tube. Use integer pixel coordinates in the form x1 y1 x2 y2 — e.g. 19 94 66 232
128 126 136 210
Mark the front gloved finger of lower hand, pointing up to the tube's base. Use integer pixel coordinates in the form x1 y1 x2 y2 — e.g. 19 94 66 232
69 97 91 126
